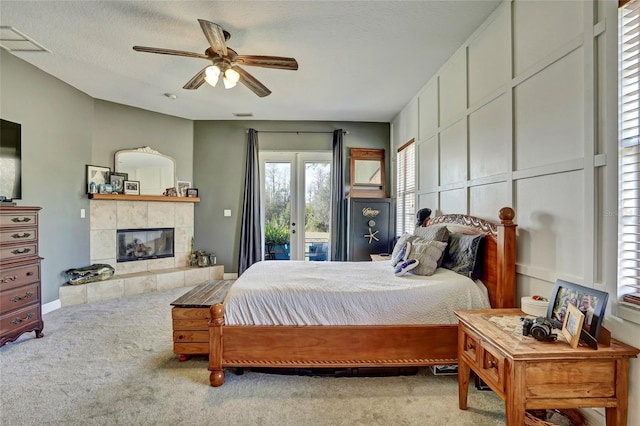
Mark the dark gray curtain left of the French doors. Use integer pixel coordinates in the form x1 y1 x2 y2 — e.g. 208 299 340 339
238 129 264 276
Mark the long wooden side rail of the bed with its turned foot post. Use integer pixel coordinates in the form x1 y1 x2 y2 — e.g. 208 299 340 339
209 304 458 386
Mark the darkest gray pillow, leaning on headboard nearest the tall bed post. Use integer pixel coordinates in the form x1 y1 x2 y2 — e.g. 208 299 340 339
442 233 484 280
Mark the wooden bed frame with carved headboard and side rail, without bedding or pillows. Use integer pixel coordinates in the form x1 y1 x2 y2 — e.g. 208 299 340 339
209 207 517 386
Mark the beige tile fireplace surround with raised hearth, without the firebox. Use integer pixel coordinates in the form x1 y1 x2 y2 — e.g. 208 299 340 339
59 200 224 306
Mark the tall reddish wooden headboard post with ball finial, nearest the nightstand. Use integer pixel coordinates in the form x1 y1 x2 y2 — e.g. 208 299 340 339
494 207 518 308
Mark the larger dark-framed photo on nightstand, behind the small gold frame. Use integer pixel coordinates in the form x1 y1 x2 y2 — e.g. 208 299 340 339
547 280 609 346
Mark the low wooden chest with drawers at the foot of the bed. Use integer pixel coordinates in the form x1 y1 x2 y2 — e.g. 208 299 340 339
171 280 233 361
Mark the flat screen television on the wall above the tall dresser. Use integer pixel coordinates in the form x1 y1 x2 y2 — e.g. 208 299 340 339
0 119 22 200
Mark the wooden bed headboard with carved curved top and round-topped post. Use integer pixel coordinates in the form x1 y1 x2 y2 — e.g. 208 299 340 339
428 207 518 308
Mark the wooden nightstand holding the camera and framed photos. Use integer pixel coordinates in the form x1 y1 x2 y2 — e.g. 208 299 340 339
455 309 640 426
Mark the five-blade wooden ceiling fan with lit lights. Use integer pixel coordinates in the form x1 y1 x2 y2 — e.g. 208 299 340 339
133 19 298 97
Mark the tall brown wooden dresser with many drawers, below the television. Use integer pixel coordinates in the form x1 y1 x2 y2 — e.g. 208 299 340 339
0 206 44 346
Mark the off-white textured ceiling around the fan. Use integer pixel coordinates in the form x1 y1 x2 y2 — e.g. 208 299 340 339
0 0 501 122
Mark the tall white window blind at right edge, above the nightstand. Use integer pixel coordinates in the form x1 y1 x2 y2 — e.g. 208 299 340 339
618 0 640 309
